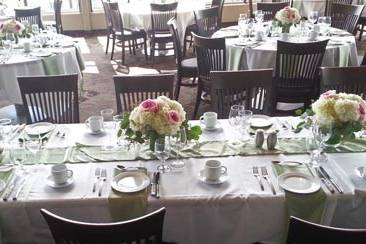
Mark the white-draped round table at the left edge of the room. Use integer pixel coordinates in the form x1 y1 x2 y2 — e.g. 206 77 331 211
0 35 84 104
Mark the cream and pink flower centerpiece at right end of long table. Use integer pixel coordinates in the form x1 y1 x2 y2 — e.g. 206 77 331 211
312 90 366 145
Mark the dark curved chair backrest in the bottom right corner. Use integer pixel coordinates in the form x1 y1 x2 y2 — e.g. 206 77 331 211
286 216 366 244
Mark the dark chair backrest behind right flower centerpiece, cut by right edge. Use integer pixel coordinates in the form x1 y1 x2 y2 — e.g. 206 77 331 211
320 66 366 99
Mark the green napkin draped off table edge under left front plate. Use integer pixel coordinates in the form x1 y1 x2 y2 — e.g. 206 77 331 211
108 169 149 221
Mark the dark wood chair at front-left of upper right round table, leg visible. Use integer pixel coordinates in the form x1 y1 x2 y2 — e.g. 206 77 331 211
193 33 226 119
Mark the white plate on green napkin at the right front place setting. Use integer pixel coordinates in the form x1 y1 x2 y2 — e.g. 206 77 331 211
278 173 320 194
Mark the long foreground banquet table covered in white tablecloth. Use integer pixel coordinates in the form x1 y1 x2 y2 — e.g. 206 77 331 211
0 117 366 244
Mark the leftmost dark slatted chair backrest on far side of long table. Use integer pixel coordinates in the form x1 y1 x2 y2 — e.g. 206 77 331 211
18 74 79 124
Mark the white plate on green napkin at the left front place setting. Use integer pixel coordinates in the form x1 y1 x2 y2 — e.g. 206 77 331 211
112 171 150 193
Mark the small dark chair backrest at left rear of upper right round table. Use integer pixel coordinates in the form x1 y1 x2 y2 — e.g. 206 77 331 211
194 7 221 37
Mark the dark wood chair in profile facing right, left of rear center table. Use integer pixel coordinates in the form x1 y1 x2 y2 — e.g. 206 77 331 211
107 2 147 64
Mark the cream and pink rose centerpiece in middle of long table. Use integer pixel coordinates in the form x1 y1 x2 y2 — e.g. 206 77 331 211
118 96 202 151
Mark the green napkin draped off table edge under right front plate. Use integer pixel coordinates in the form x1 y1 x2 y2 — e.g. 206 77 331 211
272 163 327 243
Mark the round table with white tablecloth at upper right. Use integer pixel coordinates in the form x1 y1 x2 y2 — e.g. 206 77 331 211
213 26 359 70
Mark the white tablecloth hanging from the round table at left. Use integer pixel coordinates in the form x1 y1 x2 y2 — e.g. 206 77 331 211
0 39 82 104
